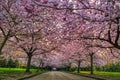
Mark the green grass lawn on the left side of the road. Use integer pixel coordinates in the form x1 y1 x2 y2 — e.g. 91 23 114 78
0 68 42 80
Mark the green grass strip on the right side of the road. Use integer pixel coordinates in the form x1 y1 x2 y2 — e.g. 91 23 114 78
74 71 120 80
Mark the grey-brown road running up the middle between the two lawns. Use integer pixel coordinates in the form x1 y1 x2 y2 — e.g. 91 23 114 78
26 71 95 80
